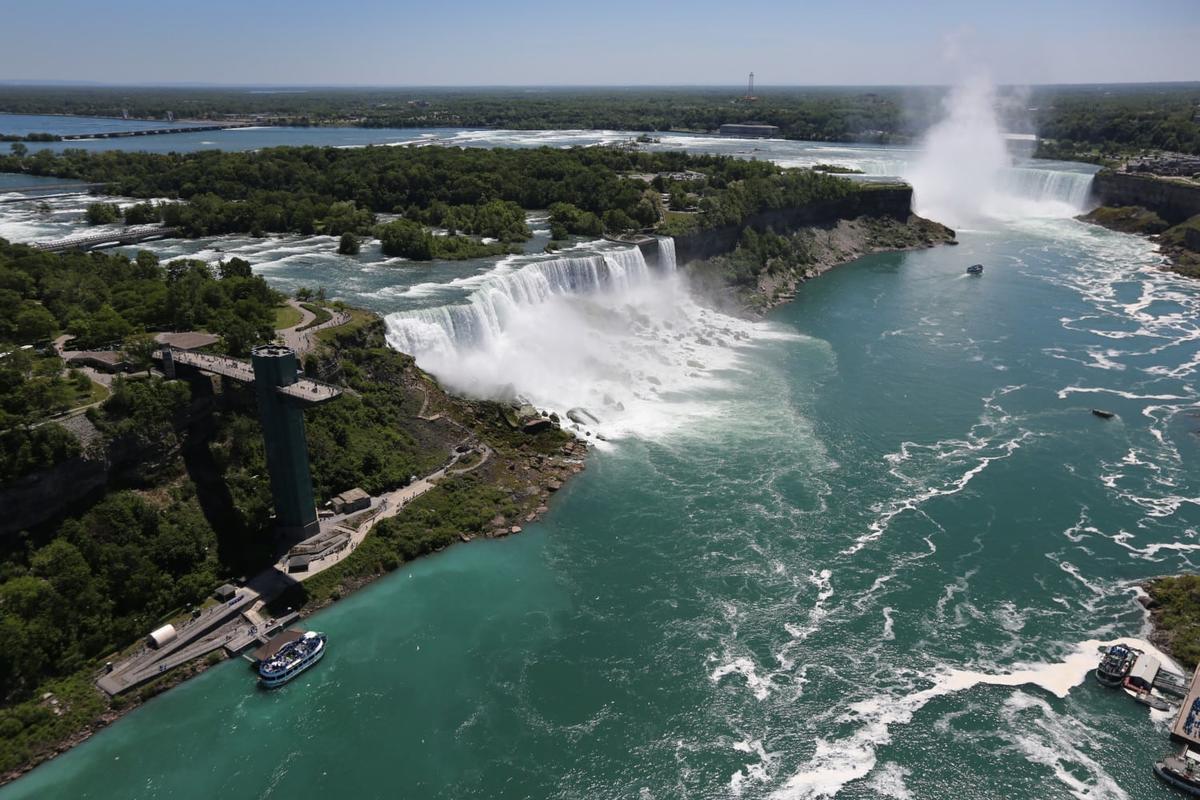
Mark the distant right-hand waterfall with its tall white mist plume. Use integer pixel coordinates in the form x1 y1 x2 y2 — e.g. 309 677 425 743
905 80 1092 227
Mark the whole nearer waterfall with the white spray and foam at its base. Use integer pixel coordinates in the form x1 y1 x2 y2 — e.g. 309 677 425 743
388 239 770 438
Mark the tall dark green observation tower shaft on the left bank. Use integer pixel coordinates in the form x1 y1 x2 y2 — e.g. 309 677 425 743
251 344 320 536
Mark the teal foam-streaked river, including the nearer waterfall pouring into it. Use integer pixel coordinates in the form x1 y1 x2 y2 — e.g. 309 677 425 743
0 128 1200 800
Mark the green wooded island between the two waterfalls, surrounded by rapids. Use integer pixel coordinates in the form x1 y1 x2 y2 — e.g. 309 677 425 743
0 148 856 248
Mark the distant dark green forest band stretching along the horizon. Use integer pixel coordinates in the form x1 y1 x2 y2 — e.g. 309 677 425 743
0 83 1200 152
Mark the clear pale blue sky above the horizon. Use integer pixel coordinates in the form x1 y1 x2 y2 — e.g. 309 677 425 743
0 0 1200 85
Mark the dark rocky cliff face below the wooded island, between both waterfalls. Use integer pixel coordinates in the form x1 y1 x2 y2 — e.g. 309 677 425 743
676 184 912 264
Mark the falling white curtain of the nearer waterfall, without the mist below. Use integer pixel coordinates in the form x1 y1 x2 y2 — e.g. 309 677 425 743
388 237 657 357
